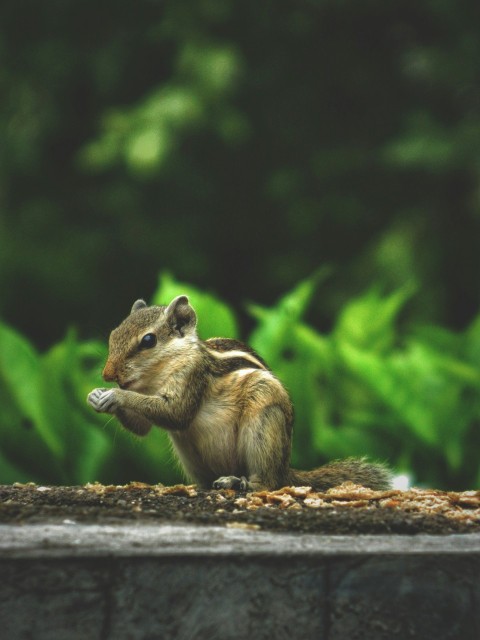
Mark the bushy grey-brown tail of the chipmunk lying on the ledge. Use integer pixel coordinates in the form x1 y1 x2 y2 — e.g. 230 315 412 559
289 458 392 491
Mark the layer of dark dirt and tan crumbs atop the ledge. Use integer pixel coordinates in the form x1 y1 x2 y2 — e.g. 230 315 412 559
0 482 480 535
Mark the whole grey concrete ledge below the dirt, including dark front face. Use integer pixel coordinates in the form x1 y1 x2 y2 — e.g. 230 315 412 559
0 523 480 640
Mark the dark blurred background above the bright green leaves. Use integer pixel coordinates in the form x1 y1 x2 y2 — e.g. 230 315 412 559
0 0 480 348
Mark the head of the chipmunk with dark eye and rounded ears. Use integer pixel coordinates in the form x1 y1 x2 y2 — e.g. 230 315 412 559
103 296 198 393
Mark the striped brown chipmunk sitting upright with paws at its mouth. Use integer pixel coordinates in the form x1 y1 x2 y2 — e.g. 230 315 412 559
87 295 390 491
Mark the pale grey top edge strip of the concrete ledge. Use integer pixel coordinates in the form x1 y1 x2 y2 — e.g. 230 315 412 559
0 522 480 558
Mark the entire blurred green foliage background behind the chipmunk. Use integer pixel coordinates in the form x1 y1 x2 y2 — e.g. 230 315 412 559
0 0 480 488
